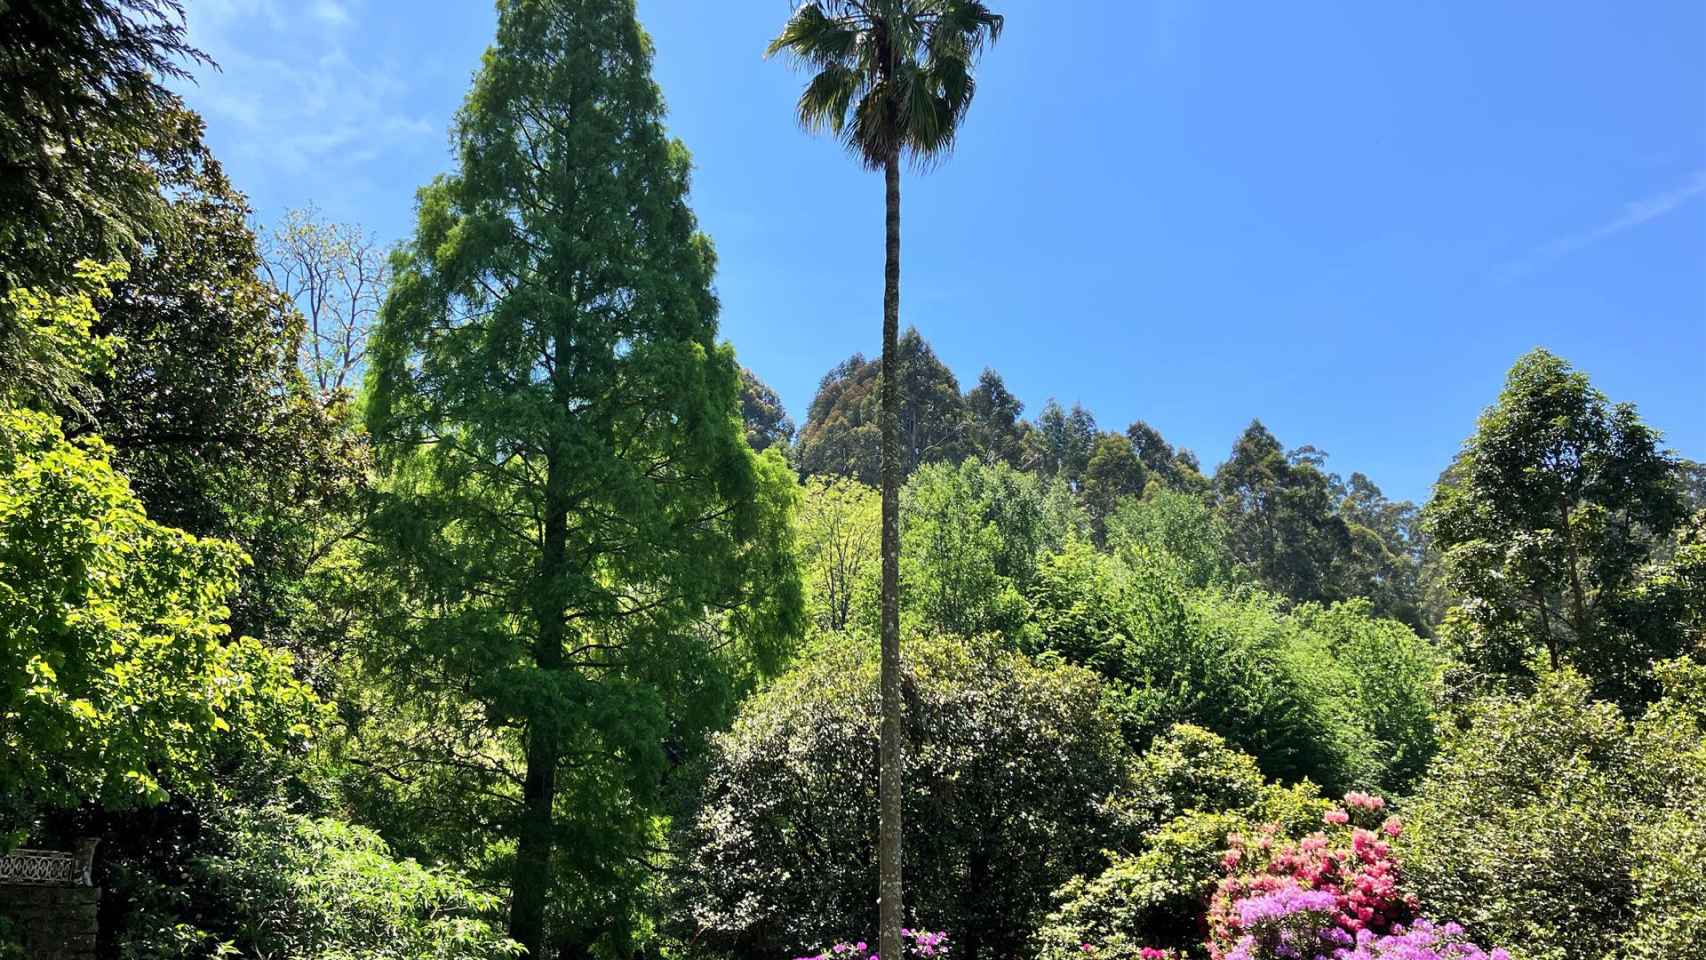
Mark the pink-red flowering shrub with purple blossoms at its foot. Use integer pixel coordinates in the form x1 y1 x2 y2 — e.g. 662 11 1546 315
1208 793 1416 960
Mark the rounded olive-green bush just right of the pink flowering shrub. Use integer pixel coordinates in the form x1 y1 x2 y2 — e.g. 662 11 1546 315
1401 672 1634 960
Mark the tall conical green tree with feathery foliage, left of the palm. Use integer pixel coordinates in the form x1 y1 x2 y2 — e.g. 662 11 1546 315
367 0 802 957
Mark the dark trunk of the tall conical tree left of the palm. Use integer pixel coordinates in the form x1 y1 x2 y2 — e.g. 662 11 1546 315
510 410 568 960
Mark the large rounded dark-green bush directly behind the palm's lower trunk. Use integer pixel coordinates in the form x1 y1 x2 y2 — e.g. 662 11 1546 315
677 636 1128 958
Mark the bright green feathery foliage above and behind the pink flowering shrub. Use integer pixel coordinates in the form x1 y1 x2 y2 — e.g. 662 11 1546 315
1022 544 1438 789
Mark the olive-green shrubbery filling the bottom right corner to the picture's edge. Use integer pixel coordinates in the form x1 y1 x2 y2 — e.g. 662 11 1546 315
1401 662 1706 960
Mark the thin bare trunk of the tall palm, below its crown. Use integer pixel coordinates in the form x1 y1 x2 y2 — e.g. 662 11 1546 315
877 145 902 960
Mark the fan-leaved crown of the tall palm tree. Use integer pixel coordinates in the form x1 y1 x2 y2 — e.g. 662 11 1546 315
768 0 1003 171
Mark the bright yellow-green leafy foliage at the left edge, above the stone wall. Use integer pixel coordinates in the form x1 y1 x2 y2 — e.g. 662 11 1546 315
0 408 316 827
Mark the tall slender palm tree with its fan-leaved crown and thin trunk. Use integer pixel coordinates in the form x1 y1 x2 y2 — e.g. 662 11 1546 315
769 0 1003 960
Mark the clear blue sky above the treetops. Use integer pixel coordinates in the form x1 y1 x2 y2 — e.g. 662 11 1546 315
186 0 1706 498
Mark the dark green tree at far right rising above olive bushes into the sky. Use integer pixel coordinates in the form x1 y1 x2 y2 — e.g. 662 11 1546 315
1428 350 1701 706
